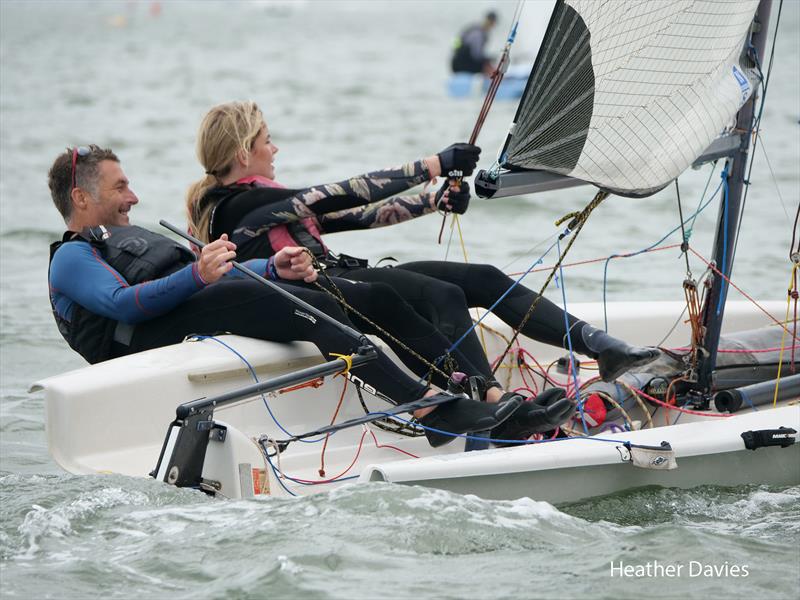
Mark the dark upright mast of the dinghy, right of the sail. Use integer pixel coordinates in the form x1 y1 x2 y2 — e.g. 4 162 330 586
690 0 772 400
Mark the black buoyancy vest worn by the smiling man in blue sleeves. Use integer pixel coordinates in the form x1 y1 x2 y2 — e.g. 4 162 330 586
48 225 195 364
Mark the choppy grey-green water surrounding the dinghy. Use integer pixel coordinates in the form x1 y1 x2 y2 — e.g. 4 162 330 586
0 0 800 598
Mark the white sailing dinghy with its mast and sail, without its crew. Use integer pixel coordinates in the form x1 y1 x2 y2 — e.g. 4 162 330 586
32 0 800 502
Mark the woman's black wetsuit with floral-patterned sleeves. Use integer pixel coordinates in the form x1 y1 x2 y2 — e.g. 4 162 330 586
201 161 594 386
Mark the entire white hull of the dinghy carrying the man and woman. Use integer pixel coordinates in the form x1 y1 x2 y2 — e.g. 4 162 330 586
32 303 800 502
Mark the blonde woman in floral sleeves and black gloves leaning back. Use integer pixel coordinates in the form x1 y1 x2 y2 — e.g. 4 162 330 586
187 101 658 400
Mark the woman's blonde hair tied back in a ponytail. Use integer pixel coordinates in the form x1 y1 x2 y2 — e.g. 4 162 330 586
186 100 264 243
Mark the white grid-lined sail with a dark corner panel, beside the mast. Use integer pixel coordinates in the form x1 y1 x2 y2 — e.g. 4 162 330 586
501 0 758 196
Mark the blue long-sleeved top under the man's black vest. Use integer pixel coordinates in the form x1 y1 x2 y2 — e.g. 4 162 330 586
49 241 269 324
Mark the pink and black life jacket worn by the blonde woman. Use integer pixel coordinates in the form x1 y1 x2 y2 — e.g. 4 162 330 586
208 175 329 261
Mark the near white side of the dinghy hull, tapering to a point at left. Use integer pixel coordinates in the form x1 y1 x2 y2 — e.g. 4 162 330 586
360 406 800 503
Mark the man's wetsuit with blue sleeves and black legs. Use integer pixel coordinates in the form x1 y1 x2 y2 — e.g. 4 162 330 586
49 225 427 403
